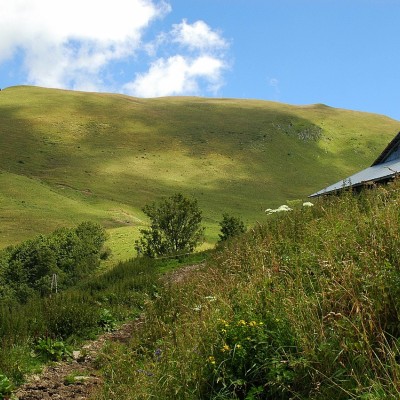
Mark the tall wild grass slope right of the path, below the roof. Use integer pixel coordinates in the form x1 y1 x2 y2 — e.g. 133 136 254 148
94 183 400 400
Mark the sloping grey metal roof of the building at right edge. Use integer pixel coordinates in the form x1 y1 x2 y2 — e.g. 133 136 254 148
309 159 400 197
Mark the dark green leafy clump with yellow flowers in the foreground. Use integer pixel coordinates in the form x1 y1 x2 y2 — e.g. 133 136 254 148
208 316 304 399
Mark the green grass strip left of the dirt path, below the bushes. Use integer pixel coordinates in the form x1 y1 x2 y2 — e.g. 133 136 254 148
0 252 208 385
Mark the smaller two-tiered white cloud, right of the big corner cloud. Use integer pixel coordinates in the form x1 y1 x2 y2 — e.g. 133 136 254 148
125 20 228 97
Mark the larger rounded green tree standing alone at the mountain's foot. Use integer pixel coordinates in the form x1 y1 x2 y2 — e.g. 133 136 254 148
135 193 204 258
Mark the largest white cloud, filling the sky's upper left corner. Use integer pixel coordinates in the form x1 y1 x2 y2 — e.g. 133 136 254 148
0 0 170 89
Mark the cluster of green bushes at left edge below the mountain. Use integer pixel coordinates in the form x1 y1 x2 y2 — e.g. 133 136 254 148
0 222 107 304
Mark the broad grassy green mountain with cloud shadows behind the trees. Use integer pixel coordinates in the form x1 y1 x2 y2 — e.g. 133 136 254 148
0 86 400 258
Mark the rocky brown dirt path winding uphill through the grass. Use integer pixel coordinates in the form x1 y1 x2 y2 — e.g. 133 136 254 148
15 264 204 400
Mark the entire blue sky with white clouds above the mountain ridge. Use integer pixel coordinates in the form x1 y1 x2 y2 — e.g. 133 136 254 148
0 0 400 120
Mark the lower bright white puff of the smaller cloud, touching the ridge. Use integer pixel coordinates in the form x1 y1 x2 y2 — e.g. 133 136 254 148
125 55 225 97
